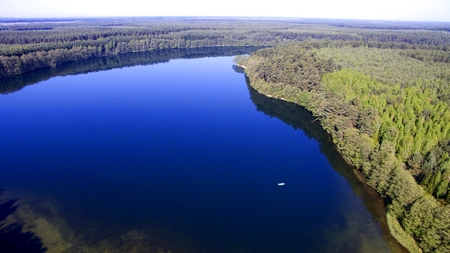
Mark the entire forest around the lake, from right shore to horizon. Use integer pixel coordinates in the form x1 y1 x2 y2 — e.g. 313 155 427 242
0 18 450 252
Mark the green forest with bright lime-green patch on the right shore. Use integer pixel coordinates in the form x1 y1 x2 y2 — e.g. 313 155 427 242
246 42 450 252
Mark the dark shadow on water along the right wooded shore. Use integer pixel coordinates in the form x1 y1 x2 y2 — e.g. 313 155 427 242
243 72 408 252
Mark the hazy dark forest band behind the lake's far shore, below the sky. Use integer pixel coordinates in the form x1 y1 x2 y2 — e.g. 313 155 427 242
0 18 450 77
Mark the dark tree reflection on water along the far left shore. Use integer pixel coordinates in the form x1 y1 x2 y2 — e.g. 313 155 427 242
0 47 260 94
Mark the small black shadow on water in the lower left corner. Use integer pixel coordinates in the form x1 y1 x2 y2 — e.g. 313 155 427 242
0 190 47 253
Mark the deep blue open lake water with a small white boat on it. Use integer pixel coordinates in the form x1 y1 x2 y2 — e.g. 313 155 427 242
0 57 400 252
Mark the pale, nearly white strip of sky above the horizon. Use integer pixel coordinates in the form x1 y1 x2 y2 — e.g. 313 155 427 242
0 0 450 22
